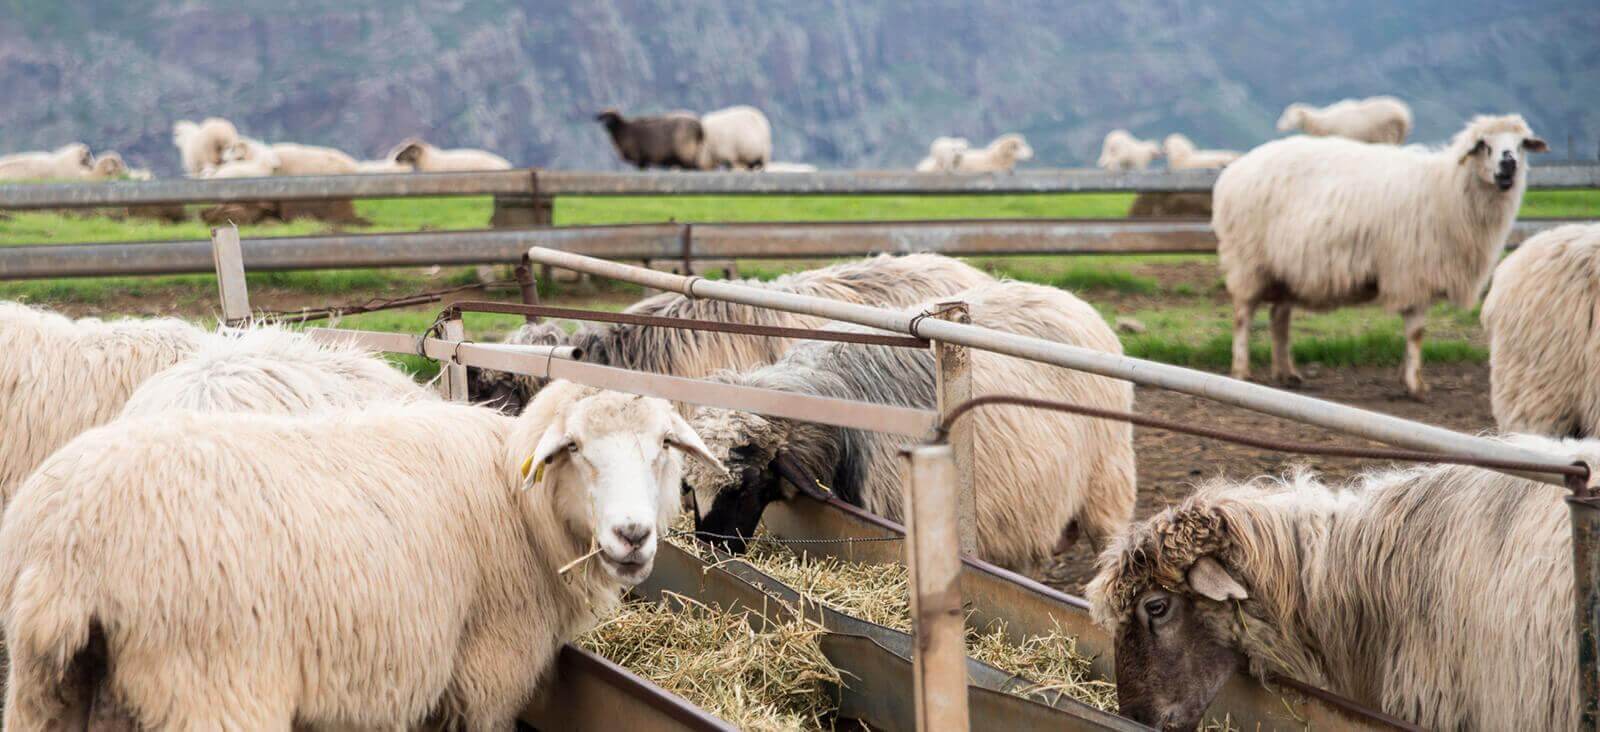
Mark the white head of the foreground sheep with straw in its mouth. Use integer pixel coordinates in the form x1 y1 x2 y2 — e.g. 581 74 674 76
525 390 722 585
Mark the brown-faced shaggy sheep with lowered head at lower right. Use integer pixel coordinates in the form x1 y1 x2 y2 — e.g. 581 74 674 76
1088 436 1600 730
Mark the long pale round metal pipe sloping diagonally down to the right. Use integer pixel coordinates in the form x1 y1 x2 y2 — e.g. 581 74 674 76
528 248 1570 486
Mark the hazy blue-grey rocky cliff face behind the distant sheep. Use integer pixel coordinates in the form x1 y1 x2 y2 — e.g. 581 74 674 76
0 0 1600 174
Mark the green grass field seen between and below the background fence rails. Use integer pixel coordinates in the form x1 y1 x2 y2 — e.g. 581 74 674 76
0 190 1600 372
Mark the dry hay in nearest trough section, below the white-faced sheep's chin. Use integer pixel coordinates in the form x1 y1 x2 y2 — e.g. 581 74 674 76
578 595 843 730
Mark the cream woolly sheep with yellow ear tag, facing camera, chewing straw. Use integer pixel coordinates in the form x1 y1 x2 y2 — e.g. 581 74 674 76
0 382 726 730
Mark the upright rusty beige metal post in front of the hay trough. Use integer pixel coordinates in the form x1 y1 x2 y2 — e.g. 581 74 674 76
902 444 970 732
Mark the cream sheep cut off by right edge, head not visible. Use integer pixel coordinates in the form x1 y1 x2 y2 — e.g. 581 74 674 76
1483 224 1600 438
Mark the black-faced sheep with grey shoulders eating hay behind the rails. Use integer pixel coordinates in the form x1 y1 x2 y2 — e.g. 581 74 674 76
686 281 1134 569
